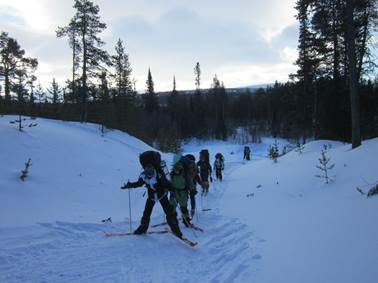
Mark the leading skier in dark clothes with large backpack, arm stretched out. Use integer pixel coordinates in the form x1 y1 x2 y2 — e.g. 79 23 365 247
121 151 182 238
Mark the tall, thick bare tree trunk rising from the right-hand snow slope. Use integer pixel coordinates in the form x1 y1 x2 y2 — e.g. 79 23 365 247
346 0 361 148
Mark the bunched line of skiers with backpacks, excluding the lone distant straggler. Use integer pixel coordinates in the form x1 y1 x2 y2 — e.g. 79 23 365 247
121 149 224 238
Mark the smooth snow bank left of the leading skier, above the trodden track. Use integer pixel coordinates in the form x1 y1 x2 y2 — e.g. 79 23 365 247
0 116 155 227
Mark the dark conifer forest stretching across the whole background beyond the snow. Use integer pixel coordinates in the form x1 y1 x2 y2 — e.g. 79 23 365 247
0 0 378 151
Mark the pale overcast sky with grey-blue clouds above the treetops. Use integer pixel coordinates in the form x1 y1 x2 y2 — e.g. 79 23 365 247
0 0 298 90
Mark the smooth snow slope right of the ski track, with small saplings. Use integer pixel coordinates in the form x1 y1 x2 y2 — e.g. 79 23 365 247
220 139 378 283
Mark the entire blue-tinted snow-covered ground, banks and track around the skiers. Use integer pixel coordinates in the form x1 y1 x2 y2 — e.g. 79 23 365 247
0 116 378 283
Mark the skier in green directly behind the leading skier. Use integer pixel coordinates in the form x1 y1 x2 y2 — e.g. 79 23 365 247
169 161 192 227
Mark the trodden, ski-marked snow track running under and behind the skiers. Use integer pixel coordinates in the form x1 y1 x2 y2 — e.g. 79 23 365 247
0 159 262 283
